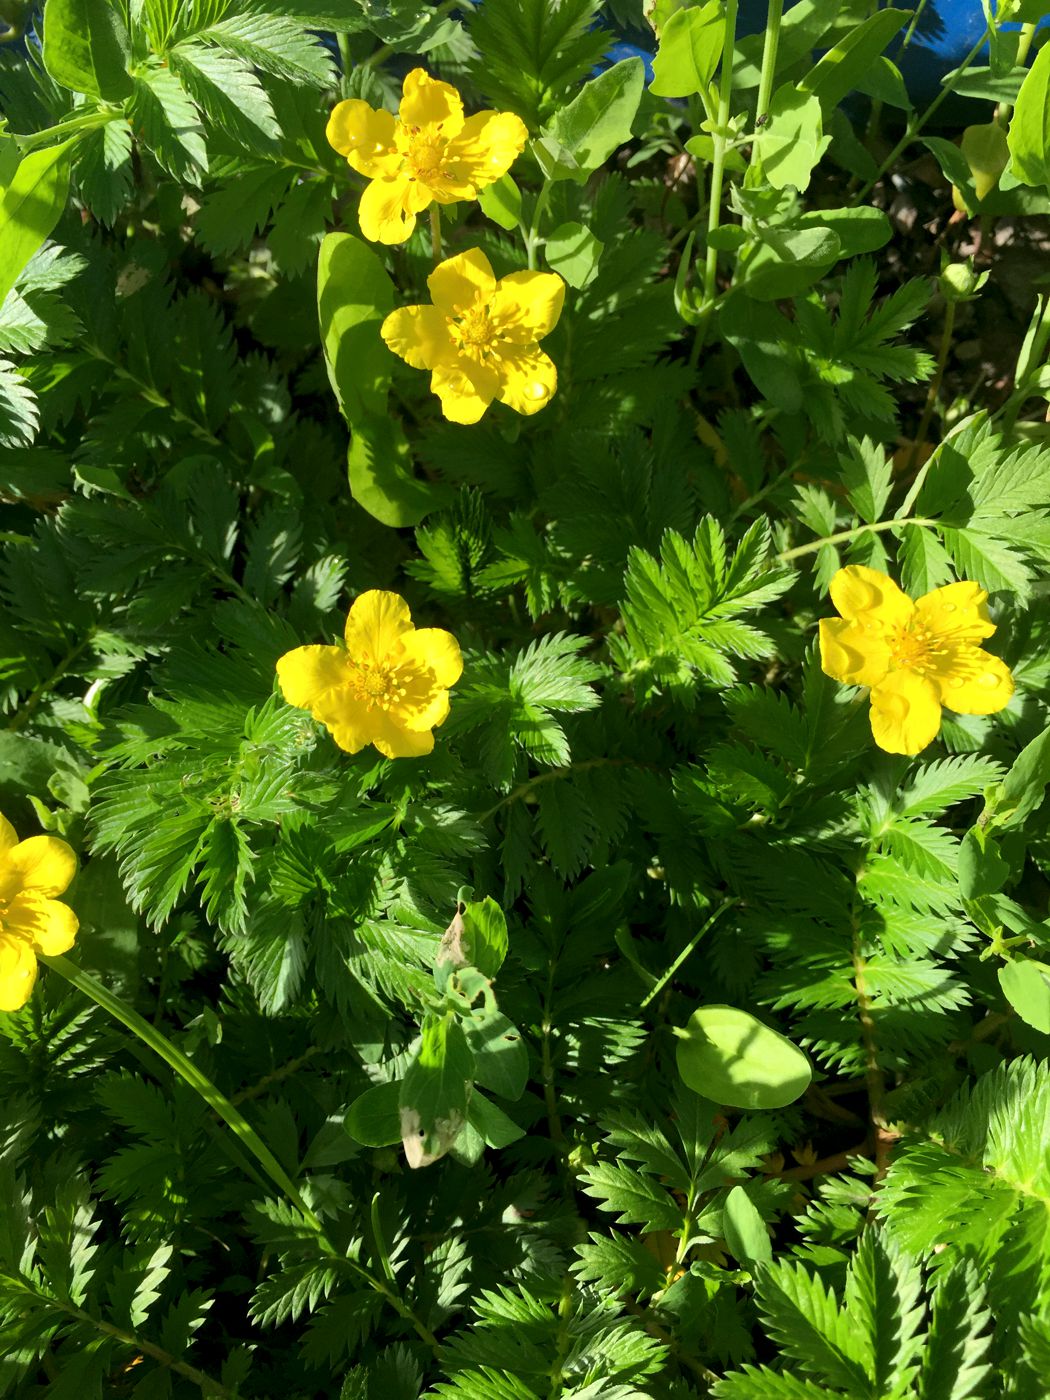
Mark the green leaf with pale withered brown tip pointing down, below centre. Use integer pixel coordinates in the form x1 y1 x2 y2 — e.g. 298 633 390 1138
398 1011 475 1166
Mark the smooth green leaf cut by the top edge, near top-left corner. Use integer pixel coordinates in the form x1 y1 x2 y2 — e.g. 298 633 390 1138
40 0 134 100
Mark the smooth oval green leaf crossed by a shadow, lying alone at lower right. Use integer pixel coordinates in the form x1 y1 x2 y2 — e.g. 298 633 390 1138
676 1005 813 1109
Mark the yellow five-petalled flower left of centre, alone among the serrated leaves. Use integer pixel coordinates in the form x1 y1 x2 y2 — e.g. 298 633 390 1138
277 588 463 759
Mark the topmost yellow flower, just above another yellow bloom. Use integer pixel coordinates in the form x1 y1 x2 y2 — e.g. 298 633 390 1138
328 69 529 244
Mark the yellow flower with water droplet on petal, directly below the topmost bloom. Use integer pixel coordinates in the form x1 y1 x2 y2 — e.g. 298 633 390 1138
381 248 566 423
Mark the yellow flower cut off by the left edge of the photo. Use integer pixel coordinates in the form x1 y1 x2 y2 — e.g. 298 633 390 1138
0 816 80 1011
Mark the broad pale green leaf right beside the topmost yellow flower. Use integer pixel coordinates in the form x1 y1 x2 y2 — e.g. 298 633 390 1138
533 59 645 183
